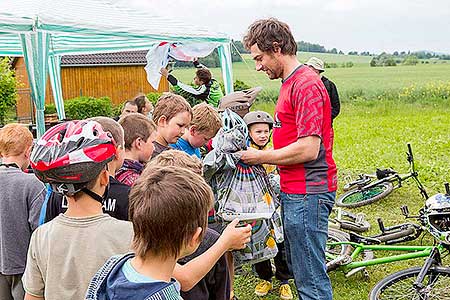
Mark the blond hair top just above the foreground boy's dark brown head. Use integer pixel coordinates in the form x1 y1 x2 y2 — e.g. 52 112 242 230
143 149 203 175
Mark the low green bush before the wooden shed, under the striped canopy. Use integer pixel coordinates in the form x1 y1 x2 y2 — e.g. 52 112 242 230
64 96 113 120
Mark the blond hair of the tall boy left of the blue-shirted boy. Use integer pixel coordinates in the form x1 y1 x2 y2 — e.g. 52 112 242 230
153 93 192 124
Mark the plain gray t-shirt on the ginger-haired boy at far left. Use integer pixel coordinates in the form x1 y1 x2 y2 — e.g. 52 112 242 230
0 166 45 275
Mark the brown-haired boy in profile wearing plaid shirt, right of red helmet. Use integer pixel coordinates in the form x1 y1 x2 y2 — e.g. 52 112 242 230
116 113 156 186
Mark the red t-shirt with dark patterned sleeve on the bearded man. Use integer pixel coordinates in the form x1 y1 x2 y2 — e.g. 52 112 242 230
273 66 337 194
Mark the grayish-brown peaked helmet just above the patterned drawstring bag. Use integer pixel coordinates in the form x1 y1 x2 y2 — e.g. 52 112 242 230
219 86 262 118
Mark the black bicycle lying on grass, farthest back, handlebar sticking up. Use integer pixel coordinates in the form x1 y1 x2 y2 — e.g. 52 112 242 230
336 144 428 208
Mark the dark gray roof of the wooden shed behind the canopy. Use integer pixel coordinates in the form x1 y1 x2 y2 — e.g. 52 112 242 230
61 50 147 67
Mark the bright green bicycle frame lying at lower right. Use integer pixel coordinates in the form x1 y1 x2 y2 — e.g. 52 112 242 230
326 242 444 273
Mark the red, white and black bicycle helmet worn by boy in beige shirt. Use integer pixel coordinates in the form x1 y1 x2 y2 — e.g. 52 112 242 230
30 121 116 201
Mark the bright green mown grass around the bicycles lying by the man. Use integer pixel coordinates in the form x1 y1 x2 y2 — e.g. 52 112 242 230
235 101 450 300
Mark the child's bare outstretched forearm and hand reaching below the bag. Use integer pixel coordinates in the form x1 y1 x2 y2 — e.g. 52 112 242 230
173 219 252 291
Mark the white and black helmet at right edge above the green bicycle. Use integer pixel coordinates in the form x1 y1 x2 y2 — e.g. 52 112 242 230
425 194 450 245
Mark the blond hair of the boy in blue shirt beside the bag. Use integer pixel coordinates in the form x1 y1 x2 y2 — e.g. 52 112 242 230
191 102 222 135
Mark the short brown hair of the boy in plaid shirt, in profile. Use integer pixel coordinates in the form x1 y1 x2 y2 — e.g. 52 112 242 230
119 113 156 150
